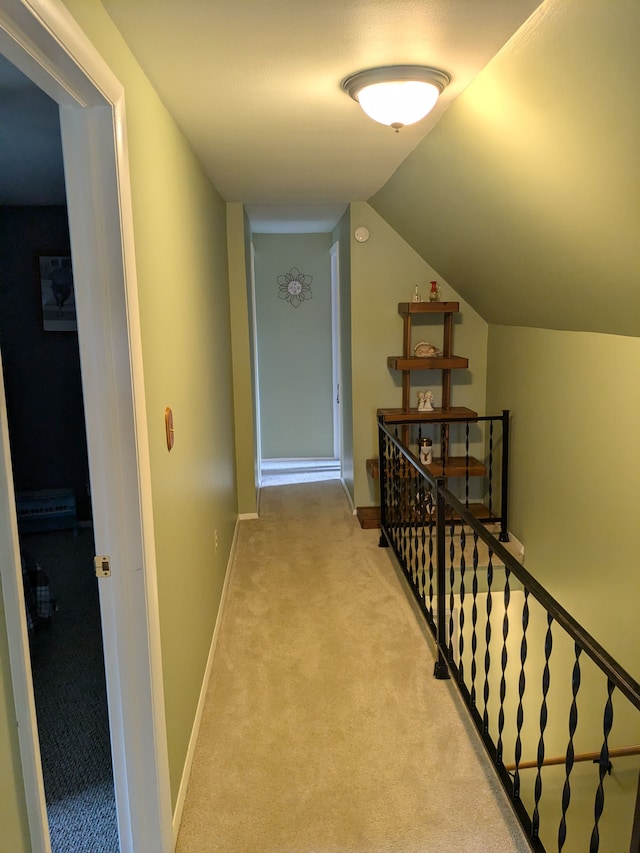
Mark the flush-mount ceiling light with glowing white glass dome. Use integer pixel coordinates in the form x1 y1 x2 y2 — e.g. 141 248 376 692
342 65 451 133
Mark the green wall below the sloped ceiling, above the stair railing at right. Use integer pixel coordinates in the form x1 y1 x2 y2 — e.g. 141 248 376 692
487 326 640 679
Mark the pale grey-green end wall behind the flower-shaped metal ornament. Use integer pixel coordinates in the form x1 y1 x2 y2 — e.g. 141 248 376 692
253 234 334 459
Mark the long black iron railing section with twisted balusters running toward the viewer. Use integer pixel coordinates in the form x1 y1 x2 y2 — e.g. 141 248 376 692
379 421 640 853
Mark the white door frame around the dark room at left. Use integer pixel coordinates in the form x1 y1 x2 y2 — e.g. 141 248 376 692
0 0 174 853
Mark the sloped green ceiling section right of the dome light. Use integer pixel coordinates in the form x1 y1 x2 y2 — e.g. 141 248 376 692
370 0 640 336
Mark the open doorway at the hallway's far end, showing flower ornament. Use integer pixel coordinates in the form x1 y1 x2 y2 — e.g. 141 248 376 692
253 233 340 485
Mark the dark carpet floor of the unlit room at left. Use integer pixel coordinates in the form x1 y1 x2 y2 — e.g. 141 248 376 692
22 529 120 853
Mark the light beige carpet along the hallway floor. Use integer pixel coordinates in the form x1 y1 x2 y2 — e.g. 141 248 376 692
177 481 529 853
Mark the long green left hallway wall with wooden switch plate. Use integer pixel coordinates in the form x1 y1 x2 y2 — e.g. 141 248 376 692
55 0 237 803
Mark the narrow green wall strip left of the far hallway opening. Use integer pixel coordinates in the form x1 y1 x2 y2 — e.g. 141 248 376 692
227 202 258 515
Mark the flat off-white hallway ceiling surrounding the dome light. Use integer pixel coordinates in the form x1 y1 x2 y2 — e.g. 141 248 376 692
0 0 540 228
